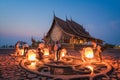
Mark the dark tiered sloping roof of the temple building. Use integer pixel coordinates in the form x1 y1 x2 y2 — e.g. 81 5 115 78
46 16 102 42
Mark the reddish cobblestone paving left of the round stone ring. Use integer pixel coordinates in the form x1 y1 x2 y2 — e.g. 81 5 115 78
0 54 50 80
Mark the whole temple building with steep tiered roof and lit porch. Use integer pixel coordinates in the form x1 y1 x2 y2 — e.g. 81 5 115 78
44 16 102 48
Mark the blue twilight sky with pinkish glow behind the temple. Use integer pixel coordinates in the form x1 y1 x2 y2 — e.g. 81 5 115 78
0 0 120 46
